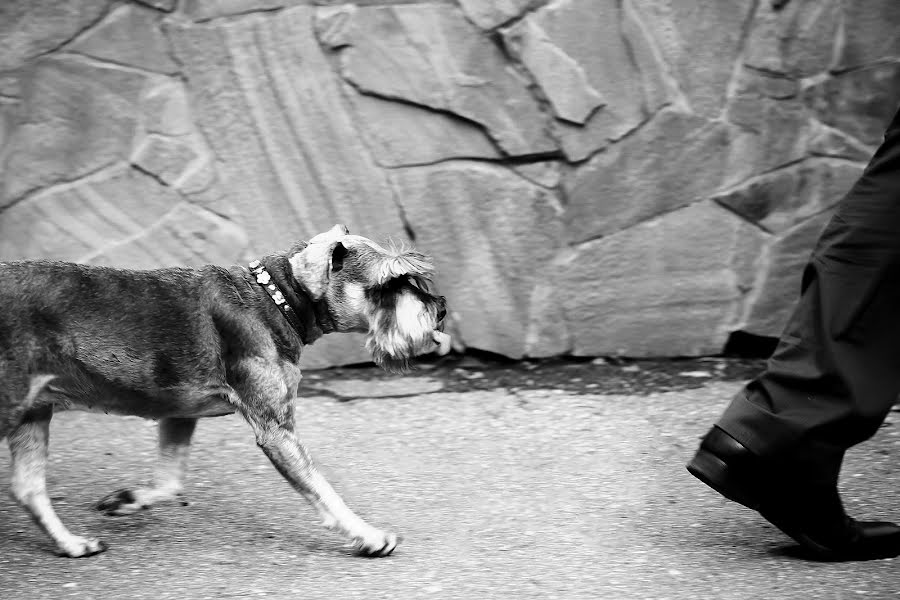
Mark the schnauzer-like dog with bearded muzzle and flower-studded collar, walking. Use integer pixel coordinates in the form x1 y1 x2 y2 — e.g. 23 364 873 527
0 225 450 557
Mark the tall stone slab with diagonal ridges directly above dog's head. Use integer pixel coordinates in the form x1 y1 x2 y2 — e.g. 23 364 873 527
169 7 405 252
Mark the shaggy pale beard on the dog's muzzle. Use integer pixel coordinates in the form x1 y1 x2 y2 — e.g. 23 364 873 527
366 293 436 373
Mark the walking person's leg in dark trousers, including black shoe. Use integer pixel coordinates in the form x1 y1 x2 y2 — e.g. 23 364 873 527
688 104 900 560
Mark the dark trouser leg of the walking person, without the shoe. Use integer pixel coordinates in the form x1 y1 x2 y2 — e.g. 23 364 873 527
718 106 900 483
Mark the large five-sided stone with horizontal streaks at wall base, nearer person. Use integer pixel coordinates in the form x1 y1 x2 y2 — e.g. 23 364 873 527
560 201 767 357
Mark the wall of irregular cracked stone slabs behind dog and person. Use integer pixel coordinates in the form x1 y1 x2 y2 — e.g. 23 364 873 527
0 0 900 366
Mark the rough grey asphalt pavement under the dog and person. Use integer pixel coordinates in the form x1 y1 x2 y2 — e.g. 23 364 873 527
0 359 900 600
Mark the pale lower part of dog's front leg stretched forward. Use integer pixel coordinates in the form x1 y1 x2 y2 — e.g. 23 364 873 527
248 416 400 556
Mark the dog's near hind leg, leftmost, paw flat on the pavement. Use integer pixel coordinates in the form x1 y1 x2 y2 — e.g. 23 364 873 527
8 406 106 557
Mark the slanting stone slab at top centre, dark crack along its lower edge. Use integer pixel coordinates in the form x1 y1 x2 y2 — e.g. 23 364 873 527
317 4 556 156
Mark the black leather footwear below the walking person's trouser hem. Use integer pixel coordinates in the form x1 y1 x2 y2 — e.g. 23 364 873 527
687 427 900 561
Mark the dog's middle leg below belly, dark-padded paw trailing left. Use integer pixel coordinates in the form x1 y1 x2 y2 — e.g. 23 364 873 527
97 418 197 516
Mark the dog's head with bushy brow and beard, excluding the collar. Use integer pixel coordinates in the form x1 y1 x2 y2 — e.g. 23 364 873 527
290 225 450 371
